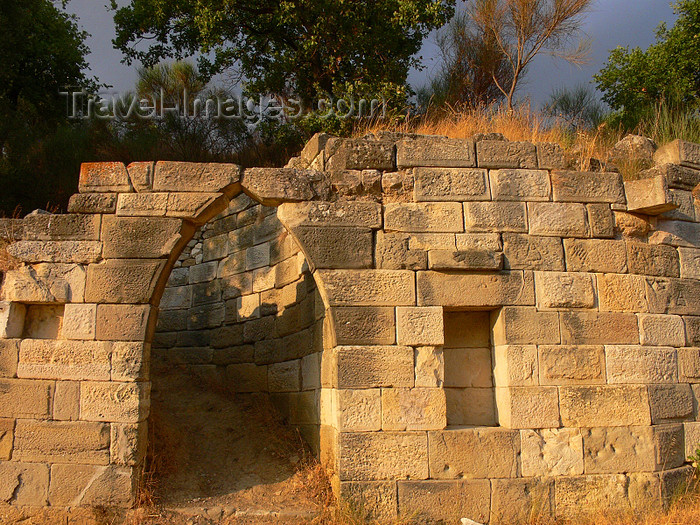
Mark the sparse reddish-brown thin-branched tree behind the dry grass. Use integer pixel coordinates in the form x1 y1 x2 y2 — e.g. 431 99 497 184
469 0 592 110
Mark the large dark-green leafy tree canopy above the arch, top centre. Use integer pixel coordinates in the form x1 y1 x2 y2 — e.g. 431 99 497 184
112 0 454 108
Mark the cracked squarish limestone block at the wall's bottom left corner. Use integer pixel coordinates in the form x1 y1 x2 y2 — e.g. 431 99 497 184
0 461 49 507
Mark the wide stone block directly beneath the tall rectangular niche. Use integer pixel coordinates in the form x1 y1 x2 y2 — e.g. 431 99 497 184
428 428 520 479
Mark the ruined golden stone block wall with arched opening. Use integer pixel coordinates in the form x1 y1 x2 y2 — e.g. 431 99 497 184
0 134 700 523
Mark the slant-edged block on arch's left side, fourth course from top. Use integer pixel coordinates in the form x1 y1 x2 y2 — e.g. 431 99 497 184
85 259 165 303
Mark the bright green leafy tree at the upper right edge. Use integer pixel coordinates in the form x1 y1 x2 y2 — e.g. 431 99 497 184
594 0 700 118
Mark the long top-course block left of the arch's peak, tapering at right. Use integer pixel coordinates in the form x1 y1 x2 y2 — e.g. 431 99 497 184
153 161 241 192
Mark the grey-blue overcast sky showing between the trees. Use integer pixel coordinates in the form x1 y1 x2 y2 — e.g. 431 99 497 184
68 0 675 105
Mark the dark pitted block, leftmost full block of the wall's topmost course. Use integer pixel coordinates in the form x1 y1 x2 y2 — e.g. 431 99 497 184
324 137 394 171
